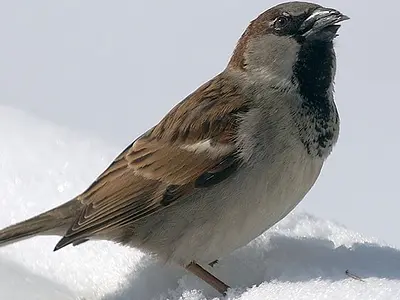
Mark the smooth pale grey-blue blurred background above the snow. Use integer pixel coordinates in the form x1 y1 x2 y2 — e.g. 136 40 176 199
0 0 400 246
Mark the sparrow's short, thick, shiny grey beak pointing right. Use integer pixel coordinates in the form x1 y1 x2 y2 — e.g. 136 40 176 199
300 7 350 40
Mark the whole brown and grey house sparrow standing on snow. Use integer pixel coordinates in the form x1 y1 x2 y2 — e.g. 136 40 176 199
0 2 348 293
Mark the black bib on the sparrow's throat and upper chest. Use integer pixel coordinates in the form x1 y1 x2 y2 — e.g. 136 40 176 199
293 40 339 156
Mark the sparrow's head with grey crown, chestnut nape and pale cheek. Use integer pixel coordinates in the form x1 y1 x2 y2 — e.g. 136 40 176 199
228 2 349 94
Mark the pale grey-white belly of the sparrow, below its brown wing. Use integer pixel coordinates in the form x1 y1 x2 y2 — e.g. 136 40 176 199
133 146 322 265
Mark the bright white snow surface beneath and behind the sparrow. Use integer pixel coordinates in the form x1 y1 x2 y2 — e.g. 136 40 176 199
0 106 400 300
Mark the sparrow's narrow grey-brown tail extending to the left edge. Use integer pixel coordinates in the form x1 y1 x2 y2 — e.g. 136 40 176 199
0 199 82 247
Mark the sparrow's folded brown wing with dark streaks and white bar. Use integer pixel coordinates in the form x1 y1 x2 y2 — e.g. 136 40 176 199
56 75 249 250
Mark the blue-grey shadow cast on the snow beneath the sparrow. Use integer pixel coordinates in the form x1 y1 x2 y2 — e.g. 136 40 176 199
102 235 400 300
